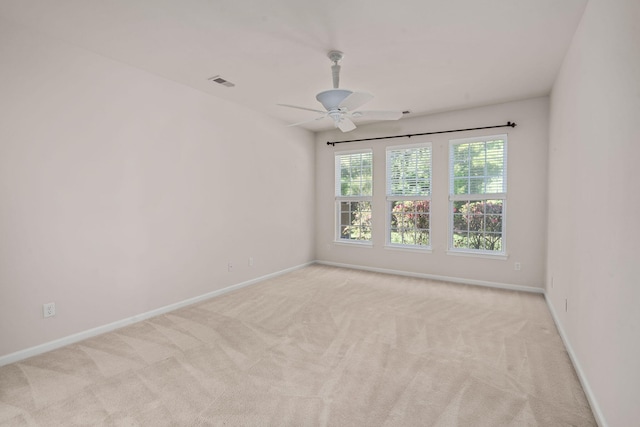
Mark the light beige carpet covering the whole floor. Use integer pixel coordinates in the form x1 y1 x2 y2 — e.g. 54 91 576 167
0 265 596 427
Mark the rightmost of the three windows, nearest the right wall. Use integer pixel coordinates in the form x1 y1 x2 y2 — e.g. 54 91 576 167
449 135 507 254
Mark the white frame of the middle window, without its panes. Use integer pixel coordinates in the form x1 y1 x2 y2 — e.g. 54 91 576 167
385 142 433 252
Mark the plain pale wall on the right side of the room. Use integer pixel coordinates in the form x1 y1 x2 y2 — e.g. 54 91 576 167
547 0 640 427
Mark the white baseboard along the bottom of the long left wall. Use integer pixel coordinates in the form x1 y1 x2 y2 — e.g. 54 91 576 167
0 262 314 366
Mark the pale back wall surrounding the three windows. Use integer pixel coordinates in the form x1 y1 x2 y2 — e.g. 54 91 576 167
316 97 549 289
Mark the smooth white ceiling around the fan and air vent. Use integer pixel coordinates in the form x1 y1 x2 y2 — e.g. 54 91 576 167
0 0 587 131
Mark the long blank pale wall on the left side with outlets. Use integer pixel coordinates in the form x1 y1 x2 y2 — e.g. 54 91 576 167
0 21 315 356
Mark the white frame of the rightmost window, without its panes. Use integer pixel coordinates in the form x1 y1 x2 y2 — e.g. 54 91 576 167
447 134 508 259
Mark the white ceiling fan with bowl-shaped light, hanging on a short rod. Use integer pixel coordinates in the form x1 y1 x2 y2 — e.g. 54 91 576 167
278 50 402 132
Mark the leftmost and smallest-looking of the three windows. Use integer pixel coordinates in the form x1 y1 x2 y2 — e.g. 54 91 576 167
336 150 373 243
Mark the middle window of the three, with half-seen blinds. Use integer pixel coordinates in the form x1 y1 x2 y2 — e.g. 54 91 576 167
387 144 431 248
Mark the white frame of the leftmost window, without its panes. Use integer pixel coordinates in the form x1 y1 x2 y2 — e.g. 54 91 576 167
334 148 374 246
